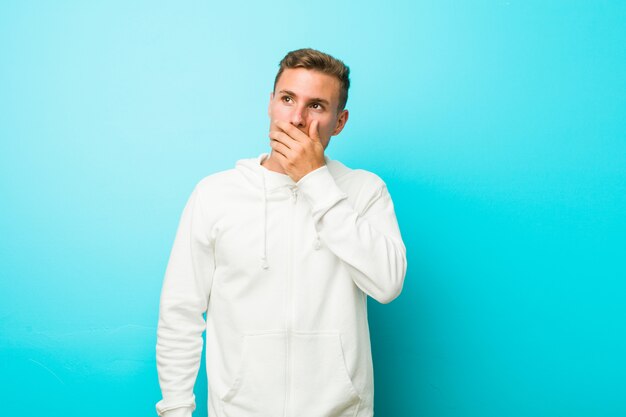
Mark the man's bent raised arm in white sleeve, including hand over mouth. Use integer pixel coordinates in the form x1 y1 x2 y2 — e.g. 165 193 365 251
270 120 406 303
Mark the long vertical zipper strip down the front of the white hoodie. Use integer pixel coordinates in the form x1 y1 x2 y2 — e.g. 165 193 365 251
283 187 298 417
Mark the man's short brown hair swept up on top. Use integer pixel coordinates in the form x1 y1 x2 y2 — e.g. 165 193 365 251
274 48 350 111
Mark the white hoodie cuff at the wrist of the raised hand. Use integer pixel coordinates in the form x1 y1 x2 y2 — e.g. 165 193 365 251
296 165 347 217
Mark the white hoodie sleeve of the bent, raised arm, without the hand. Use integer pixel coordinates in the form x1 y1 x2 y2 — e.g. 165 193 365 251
298 166 407 303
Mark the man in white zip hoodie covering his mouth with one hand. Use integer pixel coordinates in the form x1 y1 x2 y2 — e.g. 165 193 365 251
157 49 406 417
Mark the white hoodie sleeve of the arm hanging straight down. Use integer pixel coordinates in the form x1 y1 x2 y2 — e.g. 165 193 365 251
156 187 215 417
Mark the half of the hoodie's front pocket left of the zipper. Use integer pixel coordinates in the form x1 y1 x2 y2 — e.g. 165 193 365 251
221 332 286 417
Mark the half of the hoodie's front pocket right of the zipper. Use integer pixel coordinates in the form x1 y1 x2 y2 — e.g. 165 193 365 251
289 332 361 417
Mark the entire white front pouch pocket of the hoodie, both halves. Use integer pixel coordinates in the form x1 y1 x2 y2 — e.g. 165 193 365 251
221 332 361 417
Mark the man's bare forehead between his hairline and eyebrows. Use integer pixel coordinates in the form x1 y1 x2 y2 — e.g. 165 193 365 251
276 68 341 103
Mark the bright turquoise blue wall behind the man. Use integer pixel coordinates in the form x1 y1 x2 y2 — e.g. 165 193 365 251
0 0 626 417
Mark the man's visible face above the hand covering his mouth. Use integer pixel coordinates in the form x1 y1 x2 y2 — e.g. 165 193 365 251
268 68 348 149
